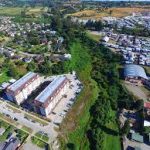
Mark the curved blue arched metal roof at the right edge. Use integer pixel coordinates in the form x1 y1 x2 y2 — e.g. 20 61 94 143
124 64 148 79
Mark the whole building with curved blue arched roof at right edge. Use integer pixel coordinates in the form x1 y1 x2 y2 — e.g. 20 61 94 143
124 64 148 85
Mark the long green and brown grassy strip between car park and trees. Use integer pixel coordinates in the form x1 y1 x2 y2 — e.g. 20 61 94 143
61 42 98 150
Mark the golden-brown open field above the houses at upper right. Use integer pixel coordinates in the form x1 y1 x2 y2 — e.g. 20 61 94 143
71 7 149 20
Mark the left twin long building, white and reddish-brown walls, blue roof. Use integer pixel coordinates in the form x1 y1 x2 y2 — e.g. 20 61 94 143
6 72 41 105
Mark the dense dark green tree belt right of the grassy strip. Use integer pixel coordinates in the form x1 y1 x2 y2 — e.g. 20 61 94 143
75 34 134 150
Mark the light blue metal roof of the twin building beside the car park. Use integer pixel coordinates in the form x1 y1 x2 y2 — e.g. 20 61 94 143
35 76 66 103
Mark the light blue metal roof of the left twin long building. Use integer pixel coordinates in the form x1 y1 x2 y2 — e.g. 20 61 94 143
9 72 36 91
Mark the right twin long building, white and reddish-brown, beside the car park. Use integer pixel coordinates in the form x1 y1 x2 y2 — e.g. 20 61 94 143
34 76 69 116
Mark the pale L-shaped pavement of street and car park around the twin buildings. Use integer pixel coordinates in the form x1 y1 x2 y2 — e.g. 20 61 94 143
0 74 82 142
